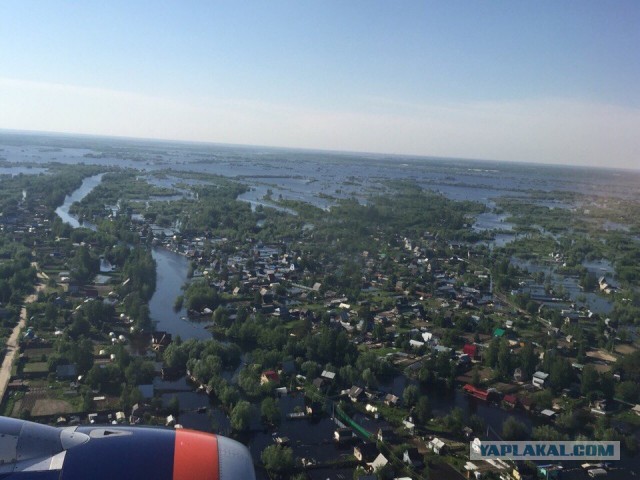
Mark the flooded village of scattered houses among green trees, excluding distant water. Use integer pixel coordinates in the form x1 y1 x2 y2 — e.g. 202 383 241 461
0 165 640 480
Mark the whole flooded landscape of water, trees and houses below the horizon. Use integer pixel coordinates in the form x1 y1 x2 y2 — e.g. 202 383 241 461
0 132 640 479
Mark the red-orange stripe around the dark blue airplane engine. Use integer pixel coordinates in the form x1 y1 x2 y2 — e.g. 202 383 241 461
173 429 220 480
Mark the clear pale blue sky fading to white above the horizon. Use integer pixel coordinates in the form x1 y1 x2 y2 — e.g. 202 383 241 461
0 0 640 169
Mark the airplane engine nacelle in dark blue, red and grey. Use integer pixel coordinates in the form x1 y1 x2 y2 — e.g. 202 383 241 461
0 417 255 480
